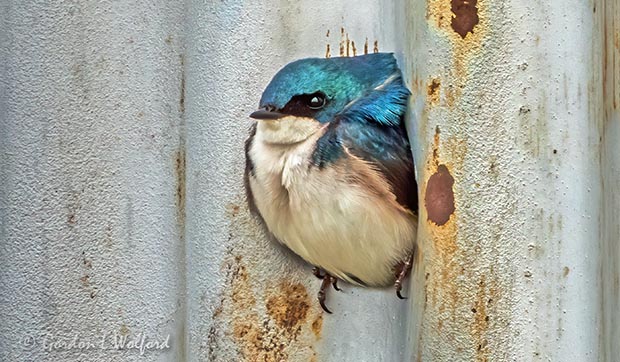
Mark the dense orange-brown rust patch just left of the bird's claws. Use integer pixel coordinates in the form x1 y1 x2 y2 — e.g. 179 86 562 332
266 282 310 336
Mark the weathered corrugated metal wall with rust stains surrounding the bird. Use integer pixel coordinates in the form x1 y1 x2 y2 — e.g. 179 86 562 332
0 0 620 361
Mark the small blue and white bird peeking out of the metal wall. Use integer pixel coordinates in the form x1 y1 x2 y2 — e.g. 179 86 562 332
245 53 418 313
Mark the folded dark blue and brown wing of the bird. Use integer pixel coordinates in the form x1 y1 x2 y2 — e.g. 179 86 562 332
313 117 418 212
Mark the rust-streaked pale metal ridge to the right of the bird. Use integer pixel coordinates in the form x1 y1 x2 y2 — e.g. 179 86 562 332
405 0 620 361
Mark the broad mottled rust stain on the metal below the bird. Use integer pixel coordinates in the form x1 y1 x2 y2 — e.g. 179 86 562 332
208 255 322 362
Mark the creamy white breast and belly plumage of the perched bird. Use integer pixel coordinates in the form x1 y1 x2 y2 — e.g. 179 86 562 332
249 119 417 286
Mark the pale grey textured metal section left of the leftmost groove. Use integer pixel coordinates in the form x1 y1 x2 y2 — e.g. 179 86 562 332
0 1 185 361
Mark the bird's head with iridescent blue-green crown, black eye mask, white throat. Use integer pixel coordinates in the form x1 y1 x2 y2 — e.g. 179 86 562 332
250 53 409 144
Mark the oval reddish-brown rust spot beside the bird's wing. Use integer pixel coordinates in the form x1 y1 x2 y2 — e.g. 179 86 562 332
424 165 455 226
